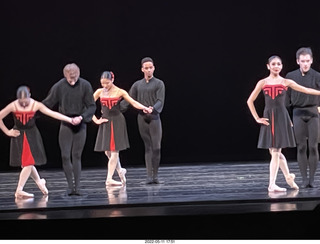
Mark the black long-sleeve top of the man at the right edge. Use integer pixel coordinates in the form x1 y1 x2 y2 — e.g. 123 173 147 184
286 68 320 108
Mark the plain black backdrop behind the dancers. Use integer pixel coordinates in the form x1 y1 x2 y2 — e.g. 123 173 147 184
0 0 320 169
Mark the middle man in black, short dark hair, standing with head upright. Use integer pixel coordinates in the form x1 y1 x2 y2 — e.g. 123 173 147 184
121 57 165 184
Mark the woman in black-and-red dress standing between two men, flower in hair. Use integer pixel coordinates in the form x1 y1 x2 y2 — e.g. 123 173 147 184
92 71 152 186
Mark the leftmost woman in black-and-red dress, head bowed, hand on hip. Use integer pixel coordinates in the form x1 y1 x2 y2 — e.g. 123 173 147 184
0 86 72 198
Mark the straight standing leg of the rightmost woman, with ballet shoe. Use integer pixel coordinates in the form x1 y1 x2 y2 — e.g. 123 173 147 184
268 148 286 191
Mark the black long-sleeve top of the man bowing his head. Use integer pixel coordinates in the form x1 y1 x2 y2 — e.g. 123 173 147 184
42 78 96 123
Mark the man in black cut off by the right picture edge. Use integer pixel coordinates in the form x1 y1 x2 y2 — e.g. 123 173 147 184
286 47 320 188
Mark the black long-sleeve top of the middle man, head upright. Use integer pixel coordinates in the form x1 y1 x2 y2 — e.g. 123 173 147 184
121 77 165 114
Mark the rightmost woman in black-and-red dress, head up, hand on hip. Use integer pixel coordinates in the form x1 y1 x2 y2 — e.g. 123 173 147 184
247 56 320 192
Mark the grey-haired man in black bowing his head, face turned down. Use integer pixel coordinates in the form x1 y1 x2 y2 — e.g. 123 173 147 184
42 63 96 195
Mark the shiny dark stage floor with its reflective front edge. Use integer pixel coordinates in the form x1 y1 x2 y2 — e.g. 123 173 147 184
0 162 320 238
